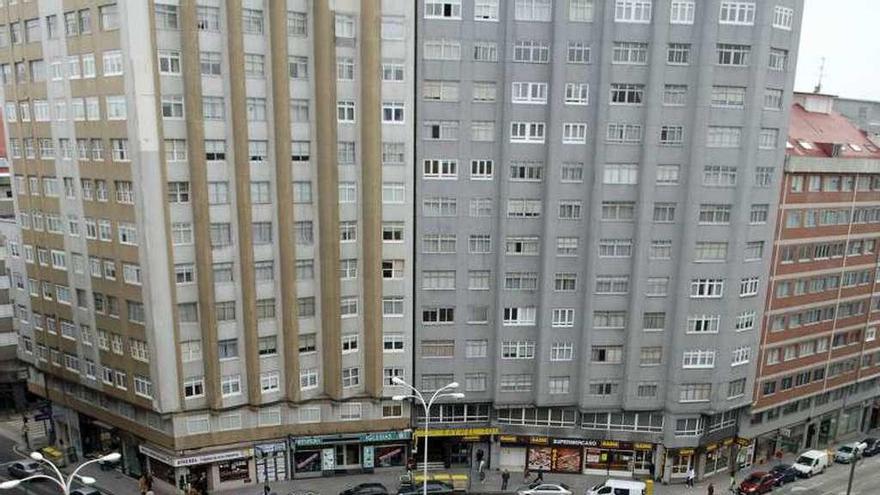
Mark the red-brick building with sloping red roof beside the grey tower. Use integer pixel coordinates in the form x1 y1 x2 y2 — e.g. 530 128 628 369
741 94 880 461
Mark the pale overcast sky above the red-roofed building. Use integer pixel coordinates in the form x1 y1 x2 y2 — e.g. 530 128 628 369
794 0 880 101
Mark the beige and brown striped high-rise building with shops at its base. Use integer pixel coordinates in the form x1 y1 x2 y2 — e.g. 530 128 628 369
0 0 415 492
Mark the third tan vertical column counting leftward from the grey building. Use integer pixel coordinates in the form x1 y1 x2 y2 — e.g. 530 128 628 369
269 1 299 402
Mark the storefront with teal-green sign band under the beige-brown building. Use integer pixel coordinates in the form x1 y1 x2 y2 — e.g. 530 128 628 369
290 431 411 478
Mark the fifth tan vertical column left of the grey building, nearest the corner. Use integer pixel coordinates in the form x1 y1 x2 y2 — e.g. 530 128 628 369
180 2 222 409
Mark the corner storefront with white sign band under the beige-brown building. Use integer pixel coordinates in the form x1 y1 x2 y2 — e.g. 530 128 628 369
138 445 256 493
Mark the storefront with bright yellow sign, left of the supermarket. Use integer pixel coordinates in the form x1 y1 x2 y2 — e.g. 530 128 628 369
413 427 499 468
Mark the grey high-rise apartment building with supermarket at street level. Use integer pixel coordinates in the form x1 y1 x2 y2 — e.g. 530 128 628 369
415 0 803 479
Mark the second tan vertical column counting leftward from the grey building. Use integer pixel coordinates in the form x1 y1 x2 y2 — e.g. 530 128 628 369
313 1 342 399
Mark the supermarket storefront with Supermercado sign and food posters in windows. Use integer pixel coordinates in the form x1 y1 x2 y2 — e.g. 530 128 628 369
498 435 654 476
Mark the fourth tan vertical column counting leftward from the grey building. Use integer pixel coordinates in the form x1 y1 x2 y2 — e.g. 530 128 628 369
225 0 261 405
